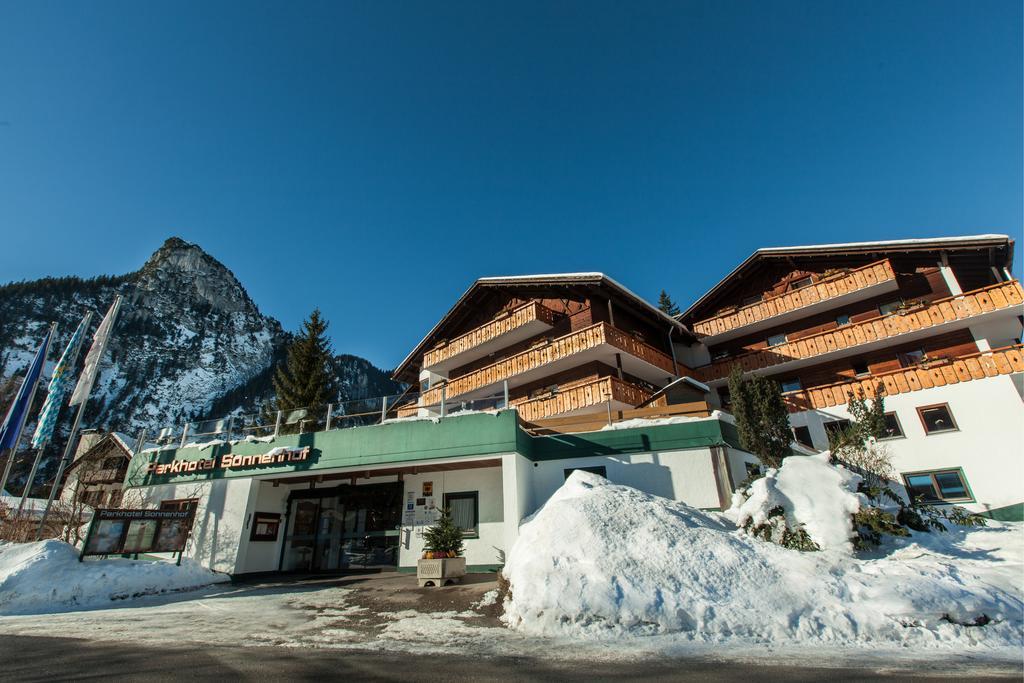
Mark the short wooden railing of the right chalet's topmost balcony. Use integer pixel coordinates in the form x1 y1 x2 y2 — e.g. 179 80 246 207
692 259 896 336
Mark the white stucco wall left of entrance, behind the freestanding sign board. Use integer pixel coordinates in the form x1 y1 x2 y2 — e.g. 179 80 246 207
121 478 255 573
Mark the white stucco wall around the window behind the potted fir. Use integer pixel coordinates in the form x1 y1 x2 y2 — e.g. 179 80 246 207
398 467 505 567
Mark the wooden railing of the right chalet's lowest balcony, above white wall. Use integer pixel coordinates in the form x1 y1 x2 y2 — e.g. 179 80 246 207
782 344 1024 413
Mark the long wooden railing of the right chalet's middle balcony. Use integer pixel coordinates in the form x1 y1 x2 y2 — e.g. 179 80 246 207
694 280 1024 382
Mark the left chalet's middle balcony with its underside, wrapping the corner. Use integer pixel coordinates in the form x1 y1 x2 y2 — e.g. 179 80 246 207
420 323 690 405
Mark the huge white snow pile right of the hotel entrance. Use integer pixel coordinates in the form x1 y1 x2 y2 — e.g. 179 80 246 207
504 470 1024 649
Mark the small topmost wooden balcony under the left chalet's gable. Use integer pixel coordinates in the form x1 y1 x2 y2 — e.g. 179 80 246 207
423 301 555 370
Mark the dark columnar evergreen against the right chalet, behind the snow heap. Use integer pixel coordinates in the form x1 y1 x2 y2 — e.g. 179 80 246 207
729 365 793 467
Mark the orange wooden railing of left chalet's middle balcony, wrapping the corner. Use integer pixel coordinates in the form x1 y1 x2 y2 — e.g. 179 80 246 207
420 323 690 405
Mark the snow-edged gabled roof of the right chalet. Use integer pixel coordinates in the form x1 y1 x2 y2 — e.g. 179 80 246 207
679 234 1014 319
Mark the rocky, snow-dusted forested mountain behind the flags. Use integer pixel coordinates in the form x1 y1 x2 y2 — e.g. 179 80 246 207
0 238 397 433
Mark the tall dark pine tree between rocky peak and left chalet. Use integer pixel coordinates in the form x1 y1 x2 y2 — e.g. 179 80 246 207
273 308 338 411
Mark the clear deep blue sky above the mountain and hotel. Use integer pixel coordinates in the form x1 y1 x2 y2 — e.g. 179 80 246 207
0 0 1024 367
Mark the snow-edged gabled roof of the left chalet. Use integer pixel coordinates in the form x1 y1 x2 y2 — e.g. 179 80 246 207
392 272 693 379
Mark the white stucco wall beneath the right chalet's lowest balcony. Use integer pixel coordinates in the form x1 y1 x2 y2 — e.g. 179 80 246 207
791 375 1024 512
